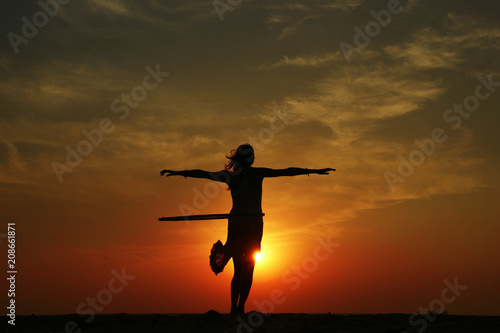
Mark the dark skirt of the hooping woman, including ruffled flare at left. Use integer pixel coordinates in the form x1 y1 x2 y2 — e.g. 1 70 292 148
210 215 264 275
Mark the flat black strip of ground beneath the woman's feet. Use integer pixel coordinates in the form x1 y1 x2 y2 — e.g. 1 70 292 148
0 310 500 333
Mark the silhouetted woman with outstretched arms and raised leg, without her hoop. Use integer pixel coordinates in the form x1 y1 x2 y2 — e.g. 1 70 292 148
160 144 335 315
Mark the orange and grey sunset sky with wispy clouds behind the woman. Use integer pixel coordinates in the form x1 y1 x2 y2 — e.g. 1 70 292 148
0 0 500 315
